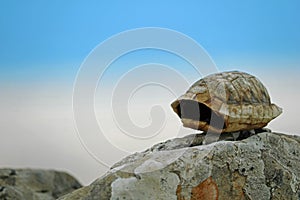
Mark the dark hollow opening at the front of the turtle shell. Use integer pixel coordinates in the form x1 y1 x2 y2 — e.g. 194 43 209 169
176 100 226 129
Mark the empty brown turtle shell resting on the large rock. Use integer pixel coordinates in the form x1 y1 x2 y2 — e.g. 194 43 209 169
171 71 282 132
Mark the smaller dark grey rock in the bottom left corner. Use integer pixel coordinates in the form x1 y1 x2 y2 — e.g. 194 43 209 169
0 169 81 200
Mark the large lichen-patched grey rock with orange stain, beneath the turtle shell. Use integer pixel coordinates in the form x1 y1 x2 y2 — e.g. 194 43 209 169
59 132 300 200
